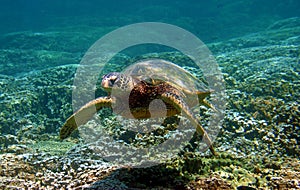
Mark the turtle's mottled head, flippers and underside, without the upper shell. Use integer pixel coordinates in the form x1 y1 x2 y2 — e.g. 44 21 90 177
60 68 216 155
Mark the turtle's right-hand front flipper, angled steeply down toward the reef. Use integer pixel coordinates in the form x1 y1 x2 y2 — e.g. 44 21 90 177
161 92 217 156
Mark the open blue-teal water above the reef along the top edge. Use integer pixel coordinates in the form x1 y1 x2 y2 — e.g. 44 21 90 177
0 0 300 42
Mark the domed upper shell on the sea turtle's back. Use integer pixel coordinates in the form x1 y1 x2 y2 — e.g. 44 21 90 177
123 59 209 94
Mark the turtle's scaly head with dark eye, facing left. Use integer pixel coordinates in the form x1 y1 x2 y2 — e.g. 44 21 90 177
101 72 135 93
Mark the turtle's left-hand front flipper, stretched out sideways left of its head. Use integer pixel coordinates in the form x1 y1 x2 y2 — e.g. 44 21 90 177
59 97 114 139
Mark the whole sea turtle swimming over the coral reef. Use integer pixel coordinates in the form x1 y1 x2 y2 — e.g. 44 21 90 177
60 59 216 155
